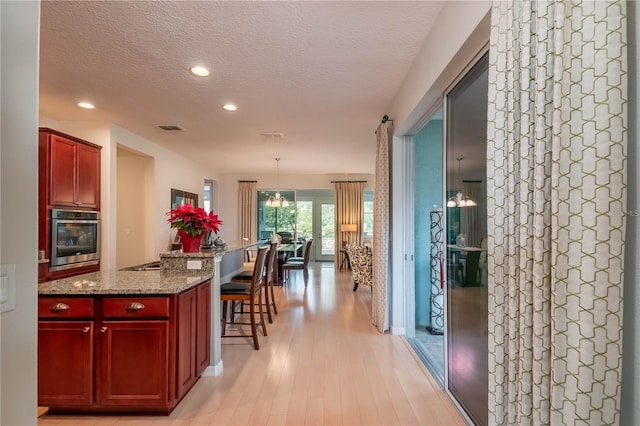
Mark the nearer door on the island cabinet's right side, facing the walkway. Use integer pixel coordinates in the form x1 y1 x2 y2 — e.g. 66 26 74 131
176 288 198 399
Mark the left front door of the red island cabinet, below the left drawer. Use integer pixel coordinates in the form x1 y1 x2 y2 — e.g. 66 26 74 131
38 321 93 407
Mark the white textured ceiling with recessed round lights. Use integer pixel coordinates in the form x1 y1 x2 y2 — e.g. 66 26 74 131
40 1 443 174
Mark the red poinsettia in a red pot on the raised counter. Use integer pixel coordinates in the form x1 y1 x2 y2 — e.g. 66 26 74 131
167 204 222 253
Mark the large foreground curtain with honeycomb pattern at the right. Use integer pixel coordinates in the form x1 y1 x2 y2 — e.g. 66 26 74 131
487 0 627 425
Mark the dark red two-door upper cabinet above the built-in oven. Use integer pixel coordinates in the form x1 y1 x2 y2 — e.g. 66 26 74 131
39 128 102 210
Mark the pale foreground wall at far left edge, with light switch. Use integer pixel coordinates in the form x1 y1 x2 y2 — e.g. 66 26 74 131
0 1 40 426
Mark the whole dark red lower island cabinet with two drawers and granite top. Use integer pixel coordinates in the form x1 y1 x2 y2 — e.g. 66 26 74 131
38 281 211 413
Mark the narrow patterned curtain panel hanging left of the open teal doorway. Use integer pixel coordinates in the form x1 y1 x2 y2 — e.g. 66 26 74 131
371 121 391 333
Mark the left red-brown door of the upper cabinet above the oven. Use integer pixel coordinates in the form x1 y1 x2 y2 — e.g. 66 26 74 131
50 135 78 206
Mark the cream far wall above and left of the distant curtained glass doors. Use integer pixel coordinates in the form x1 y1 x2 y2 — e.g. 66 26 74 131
216 171 374 241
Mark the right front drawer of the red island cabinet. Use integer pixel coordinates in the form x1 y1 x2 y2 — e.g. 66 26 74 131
102 297 169 318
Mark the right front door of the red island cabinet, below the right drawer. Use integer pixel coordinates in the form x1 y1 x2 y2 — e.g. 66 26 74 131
96 320 170 409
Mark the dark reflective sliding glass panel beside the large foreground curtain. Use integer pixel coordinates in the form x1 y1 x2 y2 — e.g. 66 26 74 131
443 50 488 425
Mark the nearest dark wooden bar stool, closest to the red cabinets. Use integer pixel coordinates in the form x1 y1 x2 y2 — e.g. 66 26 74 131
220 247 269 350
